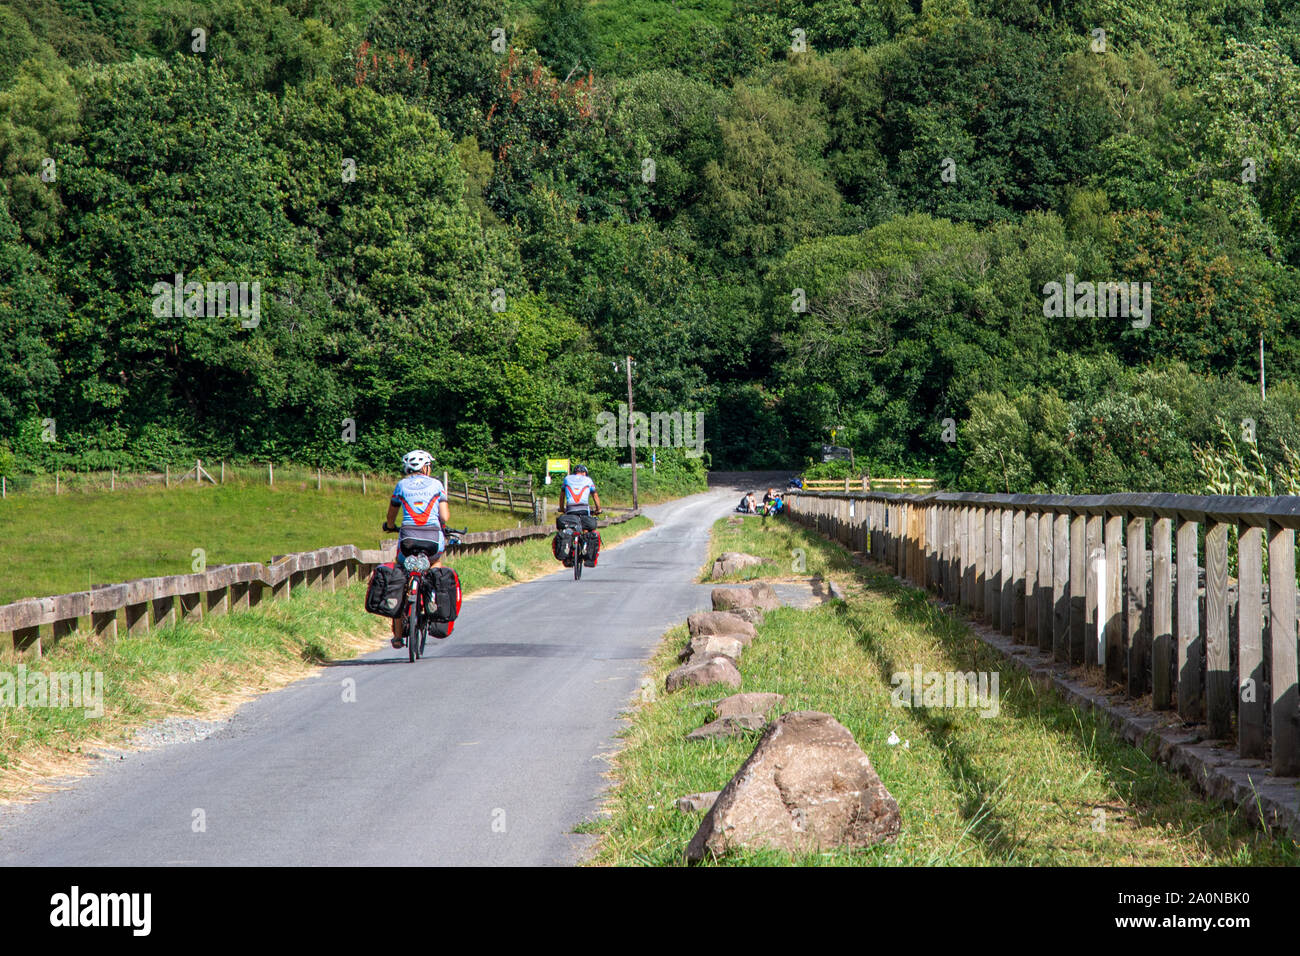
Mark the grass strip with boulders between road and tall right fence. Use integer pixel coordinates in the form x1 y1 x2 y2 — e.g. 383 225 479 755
582 520 1300 866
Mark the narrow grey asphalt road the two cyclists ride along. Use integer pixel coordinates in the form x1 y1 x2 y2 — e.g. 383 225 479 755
0 489 735 866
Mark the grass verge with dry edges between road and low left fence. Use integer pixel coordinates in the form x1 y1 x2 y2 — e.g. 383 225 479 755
0 518 651 800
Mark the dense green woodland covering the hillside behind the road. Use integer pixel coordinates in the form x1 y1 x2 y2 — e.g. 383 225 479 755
0 0 1300 492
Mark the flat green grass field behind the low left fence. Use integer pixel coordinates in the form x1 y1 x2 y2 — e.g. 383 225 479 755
0 481 524 604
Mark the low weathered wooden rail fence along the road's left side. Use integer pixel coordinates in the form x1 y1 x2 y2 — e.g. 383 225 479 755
0 511 640 657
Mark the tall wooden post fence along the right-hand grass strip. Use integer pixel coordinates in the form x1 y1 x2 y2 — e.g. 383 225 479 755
787 492 1300 777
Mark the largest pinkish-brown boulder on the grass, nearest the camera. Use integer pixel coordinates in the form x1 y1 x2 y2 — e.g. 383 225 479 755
686 710 902 861
